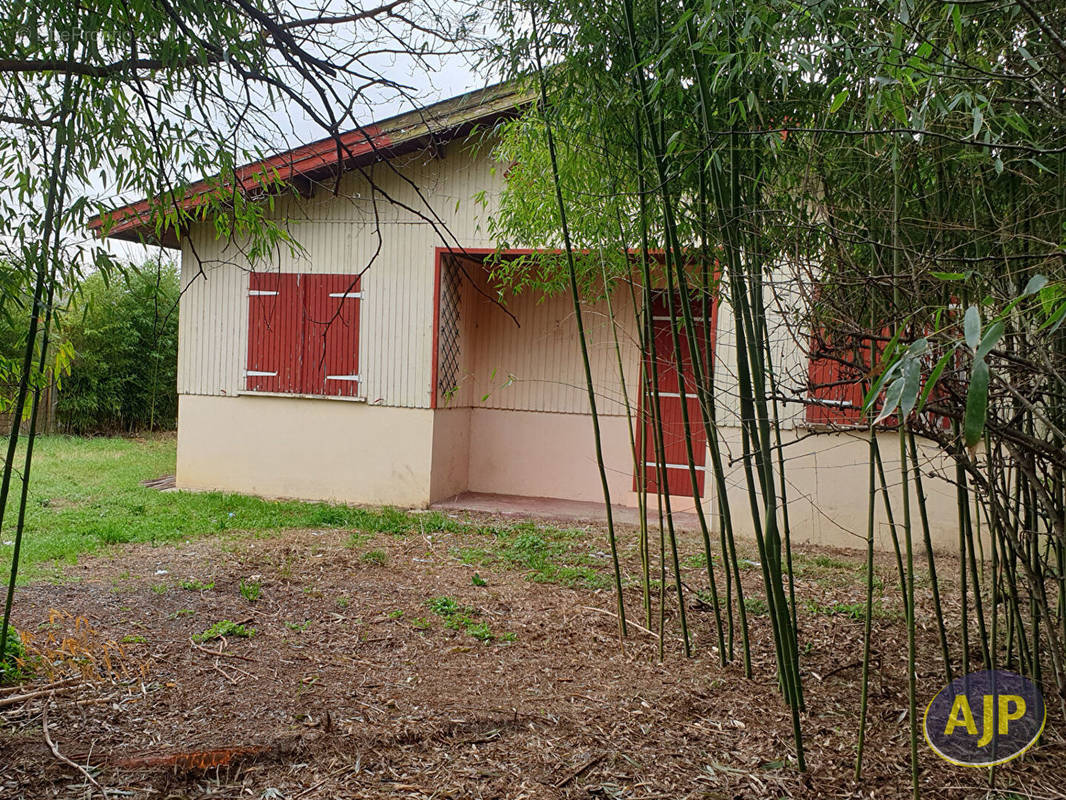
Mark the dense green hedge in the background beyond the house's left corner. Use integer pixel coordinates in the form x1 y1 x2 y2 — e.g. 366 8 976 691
56 263 179 434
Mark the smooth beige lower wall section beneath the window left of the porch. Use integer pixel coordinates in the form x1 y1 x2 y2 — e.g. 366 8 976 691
177 395 433 506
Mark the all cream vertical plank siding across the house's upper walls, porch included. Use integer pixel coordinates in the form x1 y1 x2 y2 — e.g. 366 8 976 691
178 133 807 428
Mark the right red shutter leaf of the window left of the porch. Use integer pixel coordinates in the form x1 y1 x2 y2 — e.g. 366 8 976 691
300 275 360 397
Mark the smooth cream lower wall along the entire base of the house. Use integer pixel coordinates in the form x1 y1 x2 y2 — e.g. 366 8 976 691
177 395 957 550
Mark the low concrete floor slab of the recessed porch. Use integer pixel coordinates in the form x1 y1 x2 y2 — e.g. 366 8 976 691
430 492 710 530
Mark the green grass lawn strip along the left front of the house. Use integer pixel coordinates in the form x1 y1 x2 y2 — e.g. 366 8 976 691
0 435 605 588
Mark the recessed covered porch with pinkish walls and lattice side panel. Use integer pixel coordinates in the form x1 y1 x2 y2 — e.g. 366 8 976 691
420 251 711 516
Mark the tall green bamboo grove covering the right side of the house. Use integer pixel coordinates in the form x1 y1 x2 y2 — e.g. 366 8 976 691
492 0 1066 796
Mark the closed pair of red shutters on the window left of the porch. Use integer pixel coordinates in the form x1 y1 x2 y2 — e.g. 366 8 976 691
245 273 361 397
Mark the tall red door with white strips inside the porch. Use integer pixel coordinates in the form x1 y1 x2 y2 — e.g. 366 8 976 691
633 291 717 497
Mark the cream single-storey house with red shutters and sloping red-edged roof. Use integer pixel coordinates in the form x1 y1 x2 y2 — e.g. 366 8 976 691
96 85 955 546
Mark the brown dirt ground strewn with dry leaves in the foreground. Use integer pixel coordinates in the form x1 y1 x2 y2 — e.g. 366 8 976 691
0 516 1066 800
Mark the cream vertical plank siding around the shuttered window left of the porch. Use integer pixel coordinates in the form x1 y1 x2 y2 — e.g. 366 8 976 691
178 143 502 409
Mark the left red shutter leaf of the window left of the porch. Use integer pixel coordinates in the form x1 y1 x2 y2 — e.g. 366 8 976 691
245 272 301 391
